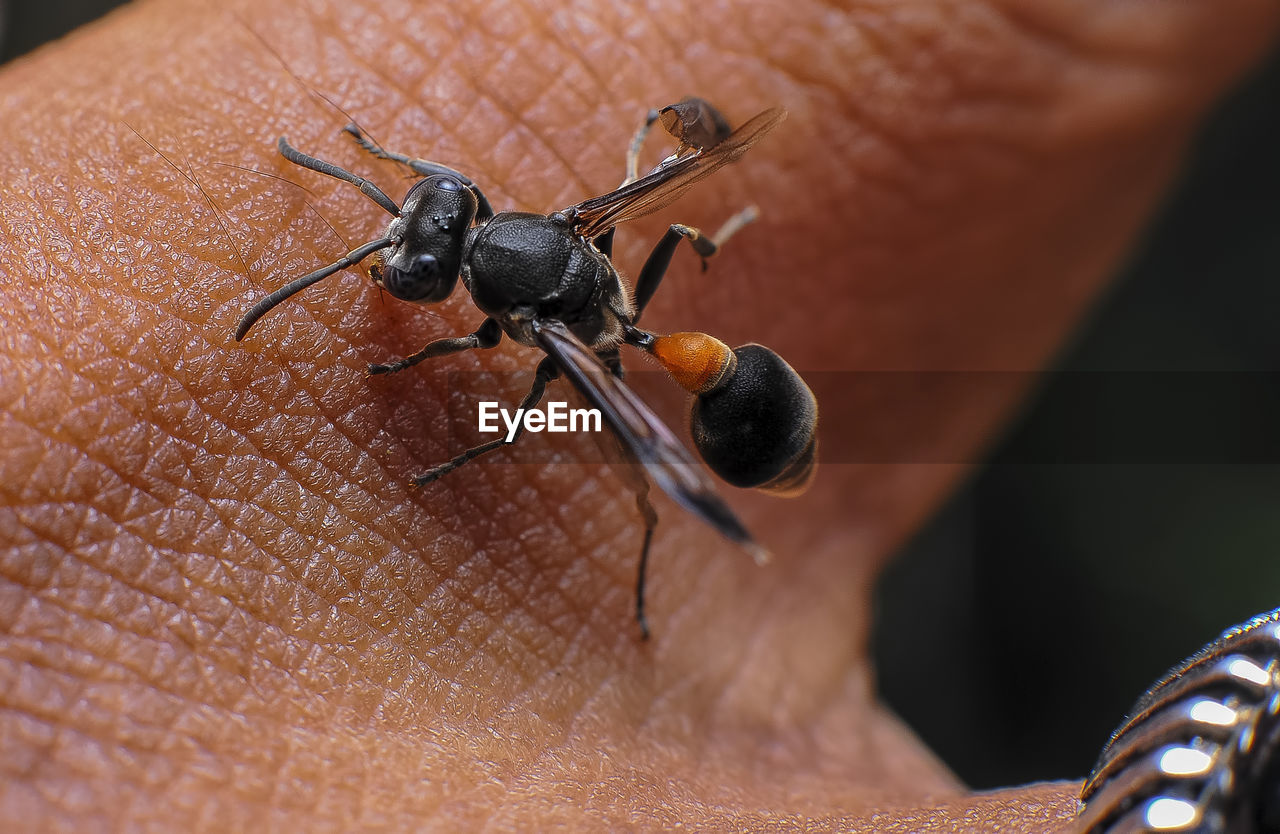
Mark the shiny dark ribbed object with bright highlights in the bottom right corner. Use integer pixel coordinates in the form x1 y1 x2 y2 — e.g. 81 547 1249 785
1078 609 1280 834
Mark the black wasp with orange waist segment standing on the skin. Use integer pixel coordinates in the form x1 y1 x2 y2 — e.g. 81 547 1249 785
236 98 818 637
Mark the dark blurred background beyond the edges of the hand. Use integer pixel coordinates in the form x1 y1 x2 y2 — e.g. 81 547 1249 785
10 0 1280 788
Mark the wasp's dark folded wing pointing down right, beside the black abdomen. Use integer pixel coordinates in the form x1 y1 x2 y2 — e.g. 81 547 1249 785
532 319 768 562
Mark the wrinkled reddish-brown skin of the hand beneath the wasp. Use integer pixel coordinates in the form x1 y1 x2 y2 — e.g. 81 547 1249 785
0 0 1280 831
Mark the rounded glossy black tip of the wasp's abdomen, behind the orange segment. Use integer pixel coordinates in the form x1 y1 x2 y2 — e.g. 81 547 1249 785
690 344 818 494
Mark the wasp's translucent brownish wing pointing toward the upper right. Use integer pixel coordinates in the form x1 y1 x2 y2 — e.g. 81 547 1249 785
561 107 787 238
